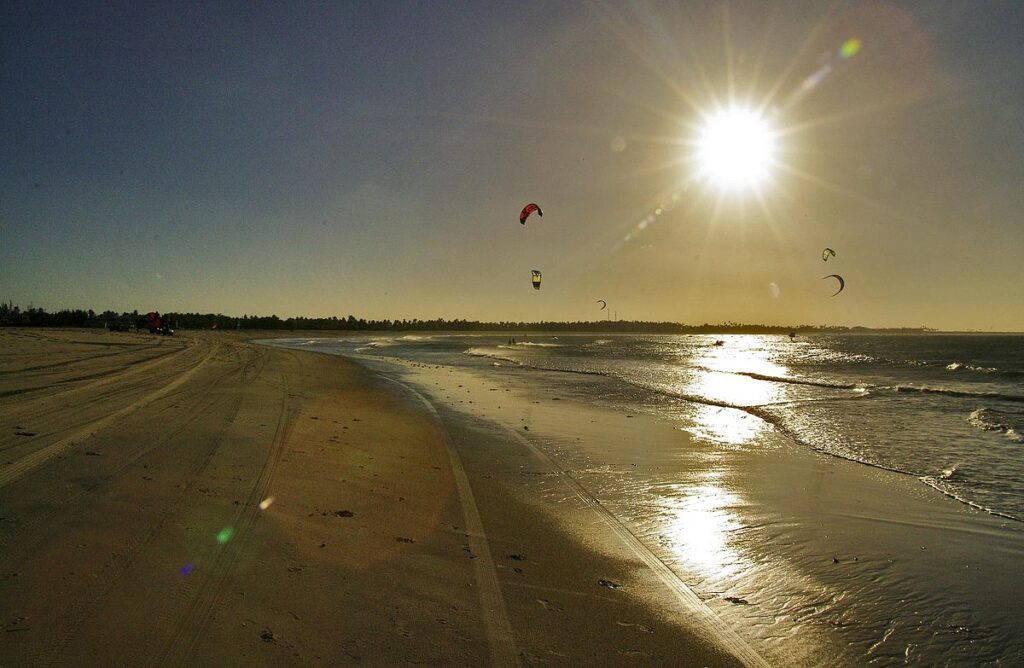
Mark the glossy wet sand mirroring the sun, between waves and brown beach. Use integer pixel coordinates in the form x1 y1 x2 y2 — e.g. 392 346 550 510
282 336 1024 665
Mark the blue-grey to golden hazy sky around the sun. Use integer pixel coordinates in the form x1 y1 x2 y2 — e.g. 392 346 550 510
0 0 1024 331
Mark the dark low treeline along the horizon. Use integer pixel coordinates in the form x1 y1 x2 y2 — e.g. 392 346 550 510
0 302 935 334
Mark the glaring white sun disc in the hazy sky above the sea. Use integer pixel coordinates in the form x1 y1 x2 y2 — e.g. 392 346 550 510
694 108 775 191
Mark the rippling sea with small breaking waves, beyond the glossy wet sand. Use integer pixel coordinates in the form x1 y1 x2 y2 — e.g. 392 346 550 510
282 335 1024 519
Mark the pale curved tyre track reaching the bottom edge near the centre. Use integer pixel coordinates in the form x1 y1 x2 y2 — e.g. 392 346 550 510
379 375 520 666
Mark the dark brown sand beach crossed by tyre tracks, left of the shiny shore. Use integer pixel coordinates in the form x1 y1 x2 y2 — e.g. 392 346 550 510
0 330 759 665
